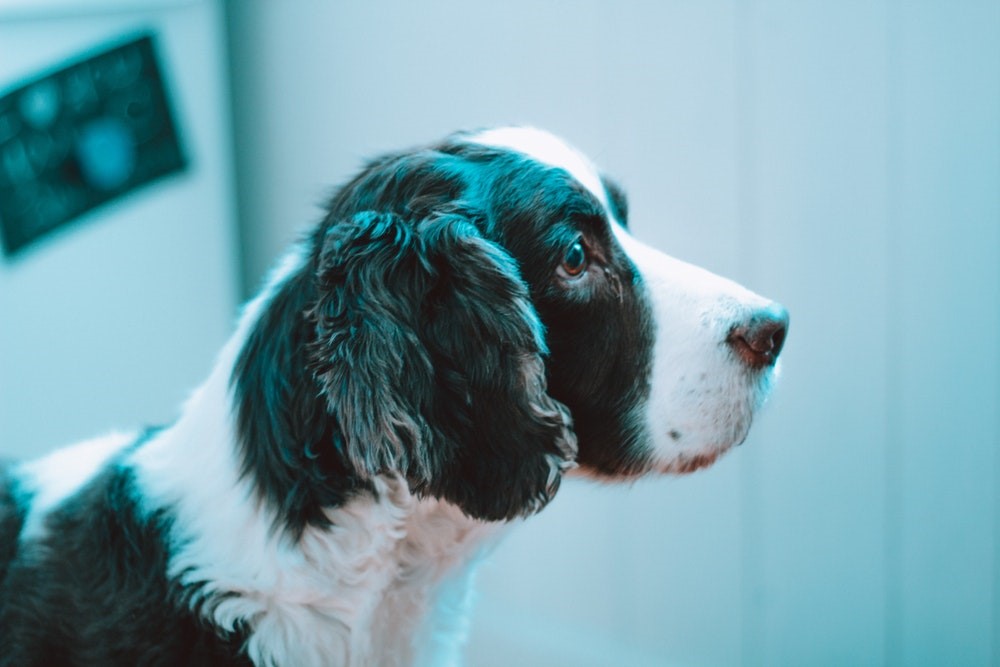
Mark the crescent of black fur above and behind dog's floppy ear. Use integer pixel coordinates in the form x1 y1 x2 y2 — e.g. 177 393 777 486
232 153 472 538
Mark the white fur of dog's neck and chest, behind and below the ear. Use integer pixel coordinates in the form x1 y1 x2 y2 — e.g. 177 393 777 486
132 294 506 665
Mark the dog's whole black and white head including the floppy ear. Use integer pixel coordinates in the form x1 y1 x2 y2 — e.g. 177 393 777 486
234 128 787 522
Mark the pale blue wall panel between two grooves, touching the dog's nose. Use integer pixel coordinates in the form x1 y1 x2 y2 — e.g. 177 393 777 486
744 1 888 666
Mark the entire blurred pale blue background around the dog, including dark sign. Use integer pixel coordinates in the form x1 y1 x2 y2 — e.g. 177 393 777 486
0 0 1000 667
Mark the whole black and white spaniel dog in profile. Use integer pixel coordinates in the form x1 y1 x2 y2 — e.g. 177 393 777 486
0 128 787 667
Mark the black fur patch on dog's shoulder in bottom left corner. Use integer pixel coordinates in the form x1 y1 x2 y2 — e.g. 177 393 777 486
0 466 250 667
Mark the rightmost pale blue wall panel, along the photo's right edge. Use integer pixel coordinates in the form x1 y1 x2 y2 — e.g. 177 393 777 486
890 2 1000 665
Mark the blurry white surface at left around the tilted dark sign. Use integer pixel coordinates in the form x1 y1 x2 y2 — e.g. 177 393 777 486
0 0 238 459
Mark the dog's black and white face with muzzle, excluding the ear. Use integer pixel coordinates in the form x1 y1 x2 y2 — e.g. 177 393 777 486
456 128 788 478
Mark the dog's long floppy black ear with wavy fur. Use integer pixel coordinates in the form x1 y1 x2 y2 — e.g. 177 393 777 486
311 213 576 520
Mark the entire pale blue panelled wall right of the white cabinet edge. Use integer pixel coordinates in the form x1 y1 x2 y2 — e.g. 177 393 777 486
229 0 1000 667
